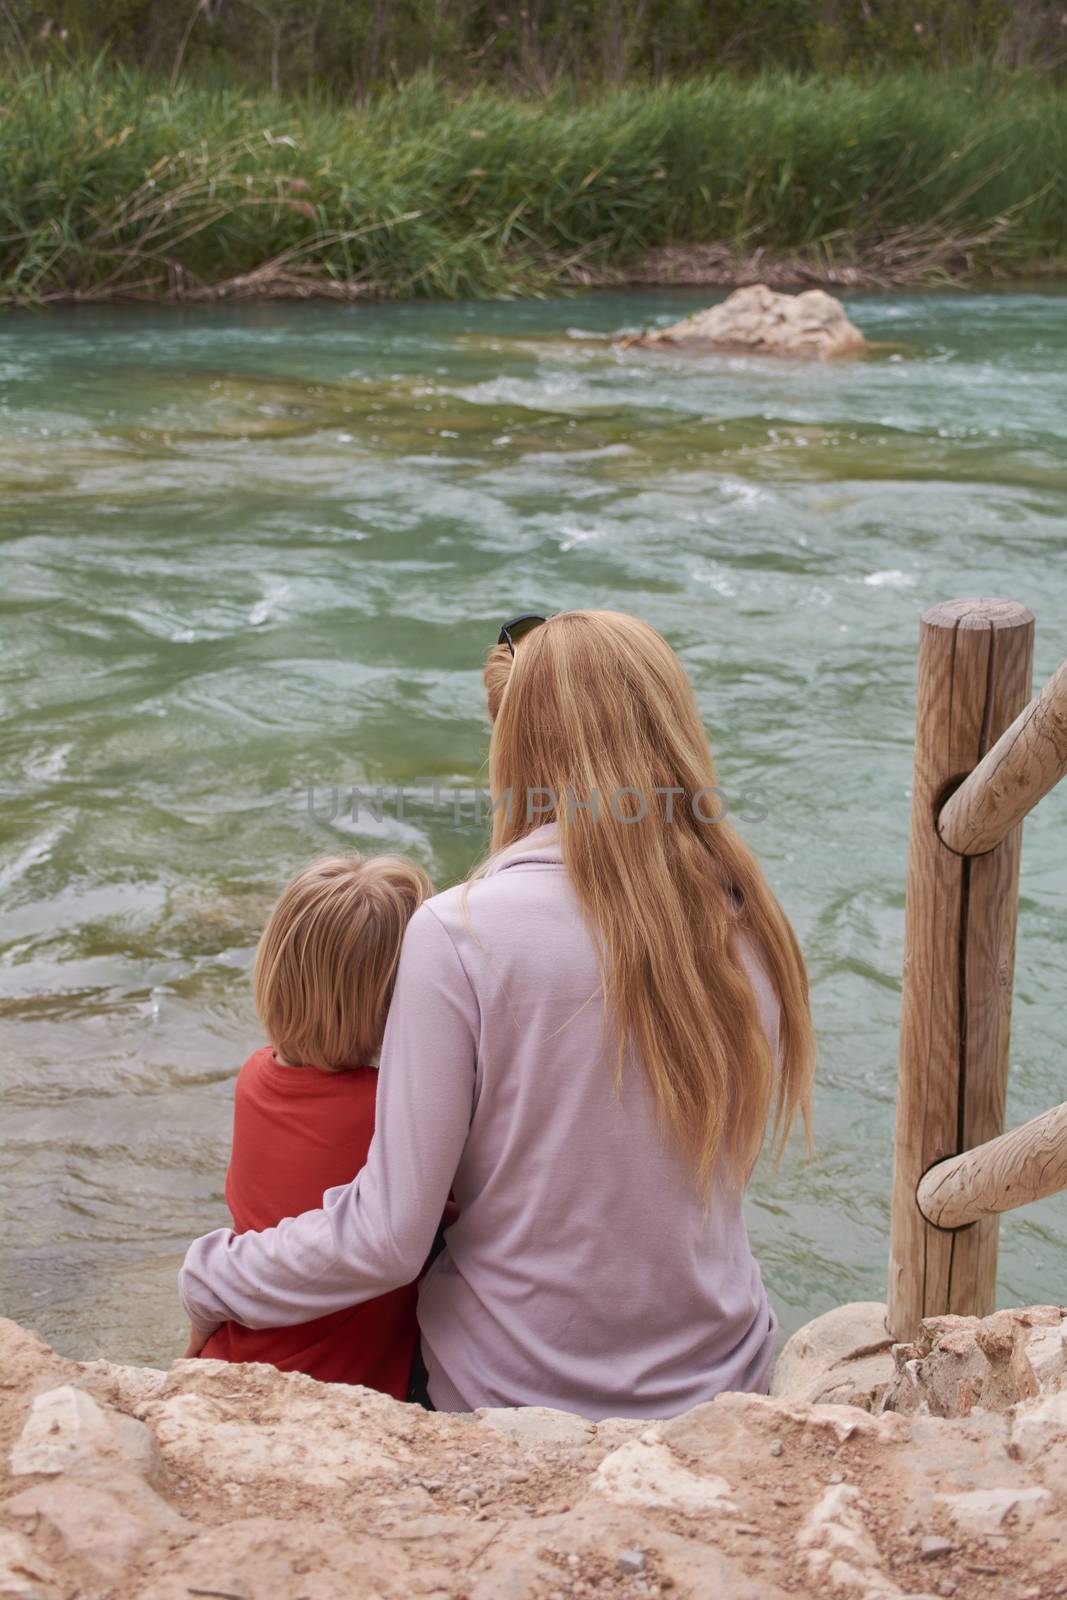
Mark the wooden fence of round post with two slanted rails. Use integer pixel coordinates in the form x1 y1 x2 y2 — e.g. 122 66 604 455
888 600 1067 1339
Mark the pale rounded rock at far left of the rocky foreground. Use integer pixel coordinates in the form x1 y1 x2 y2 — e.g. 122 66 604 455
11 1384 160 1478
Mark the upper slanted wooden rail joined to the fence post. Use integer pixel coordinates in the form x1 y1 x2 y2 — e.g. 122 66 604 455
937 661 1067 856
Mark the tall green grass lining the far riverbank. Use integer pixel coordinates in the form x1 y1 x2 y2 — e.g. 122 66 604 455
0 64 1067 304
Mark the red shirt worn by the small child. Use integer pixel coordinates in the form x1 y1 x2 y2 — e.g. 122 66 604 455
200 1045 418 1400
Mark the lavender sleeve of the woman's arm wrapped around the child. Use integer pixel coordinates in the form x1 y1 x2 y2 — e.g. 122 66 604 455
179 904 478 1330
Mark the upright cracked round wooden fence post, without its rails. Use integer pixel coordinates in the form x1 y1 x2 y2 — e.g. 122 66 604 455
886 600 1033 1339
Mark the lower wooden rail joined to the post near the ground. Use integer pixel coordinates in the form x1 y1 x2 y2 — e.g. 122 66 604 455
915 1101 1067 1229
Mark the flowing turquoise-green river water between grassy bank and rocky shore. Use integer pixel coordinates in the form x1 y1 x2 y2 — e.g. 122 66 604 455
0 291 1067 1362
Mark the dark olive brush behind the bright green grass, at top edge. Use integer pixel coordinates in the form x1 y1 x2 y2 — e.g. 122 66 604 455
8 0 1067 102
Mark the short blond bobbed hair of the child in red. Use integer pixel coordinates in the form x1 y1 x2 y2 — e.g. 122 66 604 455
253 856 434 1072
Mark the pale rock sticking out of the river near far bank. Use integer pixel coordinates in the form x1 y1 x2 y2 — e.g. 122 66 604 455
627 283 867 360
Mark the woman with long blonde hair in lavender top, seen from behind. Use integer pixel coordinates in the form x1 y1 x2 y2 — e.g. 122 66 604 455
182 611 814 1418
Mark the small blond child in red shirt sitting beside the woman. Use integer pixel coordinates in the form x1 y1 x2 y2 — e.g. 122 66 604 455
200 856 432 1400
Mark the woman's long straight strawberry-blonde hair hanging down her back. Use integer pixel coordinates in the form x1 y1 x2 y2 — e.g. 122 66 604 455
485 611 814 1197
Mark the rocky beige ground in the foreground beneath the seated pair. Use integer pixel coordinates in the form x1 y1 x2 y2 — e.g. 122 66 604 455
0 1306 1067 1600
